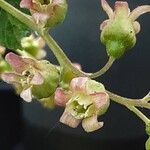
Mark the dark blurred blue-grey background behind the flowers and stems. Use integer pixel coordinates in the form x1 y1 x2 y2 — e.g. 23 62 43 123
0 0 150 150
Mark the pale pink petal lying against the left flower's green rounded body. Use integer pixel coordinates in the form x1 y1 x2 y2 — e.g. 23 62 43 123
30 72 44 85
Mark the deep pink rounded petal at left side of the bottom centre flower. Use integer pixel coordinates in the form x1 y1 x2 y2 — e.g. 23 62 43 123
54 88 68 107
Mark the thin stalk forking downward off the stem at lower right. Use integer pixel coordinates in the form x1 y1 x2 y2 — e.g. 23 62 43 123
126 105 150 125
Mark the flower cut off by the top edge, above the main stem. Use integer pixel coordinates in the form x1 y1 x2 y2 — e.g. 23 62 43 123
20 0 67 27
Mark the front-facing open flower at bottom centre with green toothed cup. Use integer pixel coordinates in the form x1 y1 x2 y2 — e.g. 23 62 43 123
55 77 109 132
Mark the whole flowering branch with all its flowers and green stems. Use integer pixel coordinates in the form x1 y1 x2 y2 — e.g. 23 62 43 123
0 0 150 141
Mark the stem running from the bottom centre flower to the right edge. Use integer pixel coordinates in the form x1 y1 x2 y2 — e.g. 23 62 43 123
106 91 150 109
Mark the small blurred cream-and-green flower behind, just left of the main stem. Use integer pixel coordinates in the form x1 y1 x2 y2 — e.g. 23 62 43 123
21 35 46 59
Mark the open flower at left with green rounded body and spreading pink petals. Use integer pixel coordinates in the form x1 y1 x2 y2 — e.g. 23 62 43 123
1 53 59 102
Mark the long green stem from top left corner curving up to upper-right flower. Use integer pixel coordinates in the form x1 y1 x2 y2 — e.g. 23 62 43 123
0 0 114 78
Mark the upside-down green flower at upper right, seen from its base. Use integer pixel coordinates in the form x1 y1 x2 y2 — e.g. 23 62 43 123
100 0 150 58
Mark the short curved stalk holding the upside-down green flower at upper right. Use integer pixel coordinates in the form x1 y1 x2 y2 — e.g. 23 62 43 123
89 57 115 78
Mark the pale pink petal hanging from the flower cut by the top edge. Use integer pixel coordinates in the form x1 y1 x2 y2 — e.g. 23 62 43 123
32 12 49 24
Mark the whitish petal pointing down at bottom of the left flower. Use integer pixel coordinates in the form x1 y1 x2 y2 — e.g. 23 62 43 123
20 87 32 102
